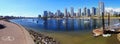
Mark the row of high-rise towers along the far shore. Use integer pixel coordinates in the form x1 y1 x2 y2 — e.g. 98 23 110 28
40 2 102 18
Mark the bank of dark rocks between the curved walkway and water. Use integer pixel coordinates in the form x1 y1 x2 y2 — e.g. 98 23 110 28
28 30 60 44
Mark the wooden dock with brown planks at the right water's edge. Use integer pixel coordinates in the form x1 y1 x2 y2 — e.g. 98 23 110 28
93 23 120 36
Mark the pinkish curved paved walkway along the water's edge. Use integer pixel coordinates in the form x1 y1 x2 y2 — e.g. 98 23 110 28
0 20 34 44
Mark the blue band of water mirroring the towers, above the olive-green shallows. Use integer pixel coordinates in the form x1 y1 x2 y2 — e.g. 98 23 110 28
12 18 120 31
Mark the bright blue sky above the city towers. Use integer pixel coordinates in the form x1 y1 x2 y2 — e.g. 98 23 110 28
0 0 120 17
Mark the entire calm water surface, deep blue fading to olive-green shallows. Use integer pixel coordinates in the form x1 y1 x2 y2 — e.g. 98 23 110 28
11 19 120 44
